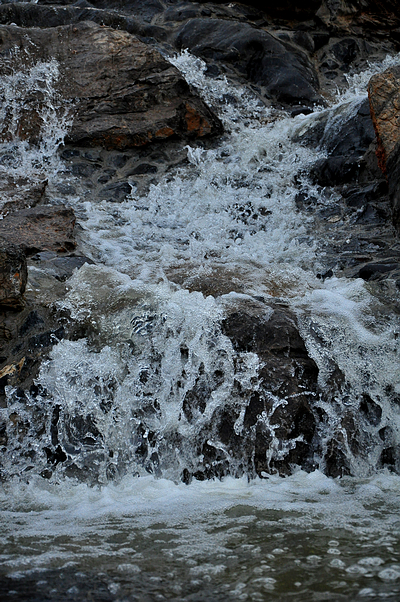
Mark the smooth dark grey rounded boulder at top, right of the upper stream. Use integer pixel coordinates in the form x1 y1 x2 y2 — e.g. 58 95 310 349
175 18 322 106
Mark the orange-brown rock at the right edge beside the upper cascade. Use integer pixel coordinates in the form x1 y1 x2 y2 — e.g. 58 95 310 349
368 66 400 230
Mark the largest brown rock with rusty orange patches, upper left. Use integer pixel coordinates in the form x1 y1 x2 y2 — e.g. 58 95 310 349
0 22 222 149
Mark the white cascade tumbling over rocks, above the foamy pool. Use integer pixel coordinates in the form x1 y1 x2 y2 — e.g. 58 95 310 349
2 52 400 483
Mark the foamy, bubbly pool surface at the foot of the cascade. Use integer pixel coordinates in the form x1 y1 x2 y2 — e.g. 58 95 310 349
0 471 400 601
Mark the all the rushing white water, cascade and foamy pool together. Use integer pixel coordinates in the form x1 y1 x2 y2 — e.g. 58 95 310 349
0 48 400 601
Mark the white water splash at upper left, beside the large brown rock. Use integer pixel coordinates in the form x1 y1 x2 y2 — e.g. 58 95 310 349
0 48 72 211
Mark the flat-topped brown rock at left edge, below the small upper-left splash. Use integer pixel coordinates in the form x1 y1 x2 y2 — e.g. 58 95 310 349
0 205 76 255
